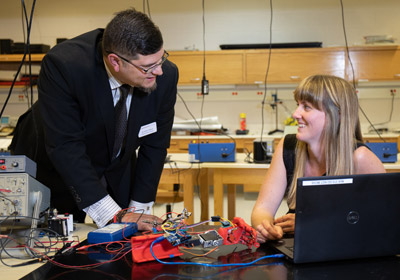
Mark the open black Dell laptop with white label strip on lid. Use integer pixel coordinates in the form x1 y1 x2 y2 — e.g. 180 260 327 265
272 173 400 263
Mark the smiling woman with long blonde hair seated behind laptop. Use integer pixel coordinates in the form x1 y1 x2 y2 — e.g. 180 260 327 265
251 75 385 242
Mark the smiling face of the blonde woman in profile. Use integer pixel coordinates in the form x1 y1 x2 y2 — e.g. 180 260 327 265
293 101 326 144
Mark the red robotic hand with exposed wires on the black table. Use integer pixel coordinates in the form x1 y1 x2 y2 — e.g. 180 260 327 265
131 208 260 262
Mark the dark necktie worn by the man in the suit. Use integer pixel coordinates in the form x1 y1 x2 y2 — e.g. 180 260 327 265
112 85 131 159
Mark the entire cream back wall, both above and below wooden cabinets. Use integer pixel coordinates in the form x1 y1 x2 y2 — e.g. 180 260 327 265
0 0 400 131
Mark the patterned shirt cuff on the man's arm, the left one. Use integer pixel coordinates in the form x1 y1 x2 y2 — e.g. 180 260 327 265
83 195 121 228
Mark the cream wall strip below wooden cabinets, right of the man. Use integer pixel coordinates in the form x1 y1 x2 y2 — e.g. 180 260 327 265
176 84 400 134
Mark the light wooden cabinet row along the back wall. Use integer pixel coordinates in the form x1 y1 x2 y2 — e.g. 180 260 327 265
0 45 400 85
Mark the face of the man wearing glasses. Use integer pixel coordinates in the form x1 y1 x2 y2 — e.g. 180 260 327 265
117 48 167 93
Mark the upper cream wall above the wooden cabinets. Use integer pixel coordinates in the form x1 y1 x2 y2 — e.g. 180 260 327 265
0 0 400 50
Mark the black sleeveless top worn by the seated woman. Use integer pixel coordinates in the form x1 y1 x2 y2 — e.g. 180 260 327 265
283 134 368 213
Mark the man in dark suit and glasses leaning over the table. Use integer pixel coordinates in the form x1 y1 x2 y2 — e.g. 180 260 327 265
10 9 178 229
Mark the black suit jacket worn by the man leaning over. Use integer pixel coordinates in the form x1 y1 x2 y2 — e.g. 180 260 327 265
10 29 178 212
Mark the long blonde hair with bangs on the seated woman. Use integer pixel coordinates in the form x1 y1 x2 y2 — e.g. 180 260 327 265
288 75 362 209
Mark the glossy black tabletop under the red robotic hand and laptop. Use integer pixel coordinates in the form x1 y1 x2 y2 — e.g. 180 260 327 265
7 224 400 280
